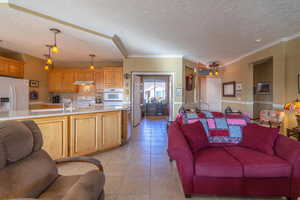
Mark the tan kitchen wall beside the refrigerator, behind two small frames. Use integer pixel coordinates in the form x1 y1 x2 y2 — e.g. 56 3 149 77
22 54 49 102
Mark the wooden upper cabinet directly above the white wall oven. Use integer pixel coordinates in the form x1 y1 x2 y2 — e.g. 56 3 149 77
104 67 123 88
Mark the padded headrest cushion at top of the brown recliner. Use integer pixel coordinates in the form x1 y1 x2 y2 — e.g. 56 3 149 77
0 121 33 162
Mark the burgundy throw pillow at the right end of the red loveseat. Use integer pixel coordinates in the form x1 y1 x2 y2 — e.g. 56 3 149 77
240 124 279 155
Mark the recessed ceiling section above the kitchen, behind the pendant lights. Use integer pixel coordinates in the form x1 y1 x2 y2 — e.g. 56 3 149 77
0 3 123 63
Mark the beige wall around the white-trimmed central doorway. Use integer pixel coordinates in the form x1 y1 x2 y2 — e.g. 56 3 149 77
123 58 184 117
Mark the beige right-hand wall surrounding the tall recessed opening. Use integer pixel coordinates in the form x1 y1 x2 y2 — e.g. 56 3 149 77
222 38 300 130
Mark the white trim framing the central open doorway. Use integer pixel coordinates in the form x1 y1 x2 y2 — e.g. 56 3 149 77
130 72 175 120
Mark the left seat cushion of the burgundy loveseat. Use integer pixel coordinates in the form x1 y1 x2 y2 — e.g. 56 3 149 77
195 147 243 178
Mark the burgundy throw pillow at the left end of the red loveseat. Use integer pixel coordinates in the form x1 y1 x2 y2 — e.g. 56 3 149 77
182 121 209 152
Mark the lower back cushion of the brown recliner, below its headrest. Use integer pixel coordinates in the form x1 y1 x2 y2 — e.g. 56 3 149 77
0 150 58 199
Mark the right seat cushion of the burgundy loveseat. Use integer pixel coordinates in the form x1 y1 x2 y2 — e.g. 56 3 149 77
224 146 292 178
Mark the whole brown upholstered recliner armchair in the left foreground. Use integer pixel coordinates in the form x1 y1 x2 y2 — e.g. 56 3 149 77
0 121 105 200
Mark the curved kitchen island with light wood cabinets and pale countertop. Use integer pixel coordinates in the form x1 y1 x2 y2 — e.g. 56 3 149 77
0 106 131 159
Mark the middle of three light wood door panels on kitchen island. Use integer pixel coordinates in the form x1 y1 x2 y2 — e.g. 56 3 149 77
70 114 98 156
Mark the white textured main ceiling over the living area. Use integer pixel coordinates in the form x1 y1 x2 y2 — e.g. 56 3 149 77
1 0 300 63
